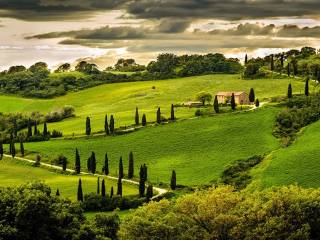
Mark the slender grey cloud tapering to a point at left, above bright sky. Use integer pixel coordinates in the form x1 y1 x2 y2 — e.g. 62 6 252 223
27 26 146 40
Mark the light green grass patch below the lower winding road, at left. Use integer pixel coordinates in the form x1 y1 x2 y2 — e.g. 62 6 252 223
0 158 138 200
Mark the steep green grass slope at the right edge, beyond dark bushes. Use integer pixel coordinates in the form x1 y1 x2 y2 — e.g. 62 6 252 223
249 122 320 189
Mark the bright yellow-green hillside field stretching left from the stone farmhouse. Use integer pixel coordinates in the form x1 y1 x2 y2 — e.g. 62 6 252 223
0 74 304 135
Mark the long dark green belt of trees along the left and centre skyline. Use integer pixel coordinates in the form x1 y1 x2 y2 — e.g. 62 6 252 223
0 54 242 98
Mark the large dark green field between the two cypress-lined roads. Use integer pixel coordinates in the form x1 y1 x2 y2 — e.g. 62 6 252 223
20 107 279 185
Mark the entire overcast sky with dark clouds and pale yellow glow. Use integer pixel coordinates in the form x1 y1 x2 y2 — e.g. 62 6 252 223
0 0 320 69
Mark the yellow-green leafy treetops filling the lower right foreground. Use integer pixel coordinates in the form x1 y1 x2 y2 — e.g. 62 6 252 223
119 186 320 239
